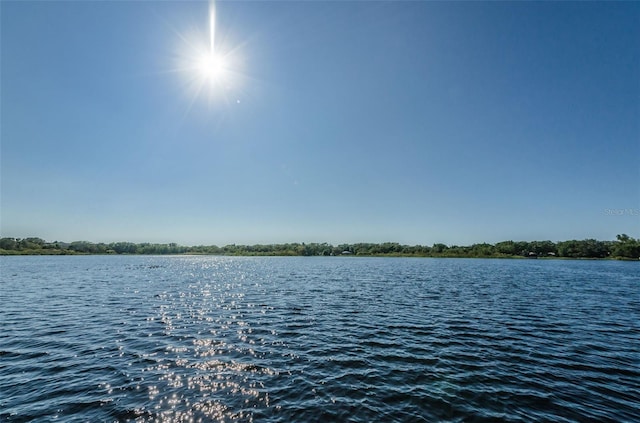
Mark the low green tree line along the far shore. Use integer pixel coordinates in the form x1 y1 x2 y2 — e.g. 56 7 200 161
0 234 640 259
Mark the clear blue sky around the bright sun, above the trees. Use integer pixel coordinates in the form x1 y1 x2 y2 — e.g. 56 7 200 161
0 1 640 245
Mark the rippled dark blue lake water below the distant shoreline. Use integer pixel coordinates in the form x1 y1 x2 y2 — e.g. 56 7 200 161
0 256 640 422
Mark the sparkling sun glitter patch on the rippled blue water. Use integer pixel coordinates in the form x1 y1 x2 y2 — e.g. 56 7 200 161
120 262 280 422
